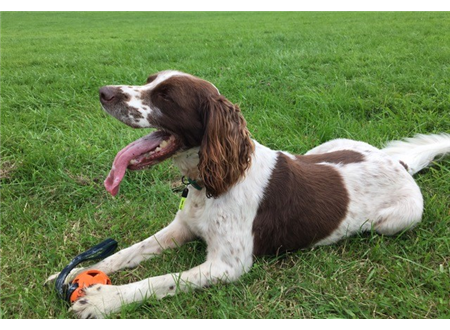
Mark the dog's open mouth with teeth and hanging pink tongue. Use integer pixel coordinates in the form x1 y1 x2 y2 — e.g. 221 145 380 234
105 131 181 196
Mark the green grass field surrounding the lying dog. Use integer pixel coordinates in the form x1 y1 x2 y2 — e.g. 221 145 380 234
0 12 450 319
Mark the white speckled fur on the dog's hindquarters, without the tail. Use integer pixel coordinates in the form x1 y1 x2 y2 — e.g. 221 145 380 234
307 139 423 241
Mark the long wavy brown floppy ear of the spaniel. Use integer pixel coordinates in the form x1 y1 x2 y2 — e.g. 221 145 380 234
198 95 255 198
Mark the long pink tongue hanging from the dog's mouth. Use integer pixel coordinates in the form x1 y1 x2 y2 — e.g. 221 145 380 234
105 132 164 196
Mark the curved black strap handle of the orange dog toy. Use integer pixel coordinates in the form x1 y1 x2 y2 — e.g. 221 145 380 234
55 238 118 301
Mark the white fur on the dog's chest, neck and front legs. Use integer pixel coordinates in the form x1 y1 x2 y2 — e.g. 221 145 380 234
65 142 277 318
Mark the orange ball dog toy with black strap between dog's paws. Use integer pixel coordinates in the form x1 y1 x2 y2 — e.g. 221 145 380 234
55 238 118 304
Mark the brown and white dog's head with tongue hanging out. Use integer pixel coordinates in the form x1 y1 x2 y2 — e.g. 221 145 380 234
100 71 254 197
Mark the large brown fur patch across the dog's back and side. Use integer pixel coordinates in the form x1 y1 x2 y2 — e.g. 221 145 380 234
253 150 364 256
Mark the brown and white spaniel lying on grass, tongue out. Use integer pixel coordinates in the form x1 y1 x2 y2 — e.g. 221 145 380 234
47 71 450 318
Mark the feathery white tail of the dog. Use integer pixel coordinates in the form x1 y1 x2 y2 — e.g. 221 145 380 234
382 134 450 175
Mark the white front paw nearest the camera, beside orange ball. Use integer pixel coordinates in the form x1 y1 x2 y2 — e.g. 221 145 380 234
70 285 122 319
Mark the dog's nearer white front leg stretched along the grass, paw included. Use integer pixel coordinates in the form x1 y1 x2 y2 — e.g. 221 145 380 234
71 260 244 318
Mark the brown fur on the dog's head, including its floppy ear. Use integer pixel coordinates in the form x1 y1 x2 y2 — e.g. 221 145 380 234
146 76 254 198
